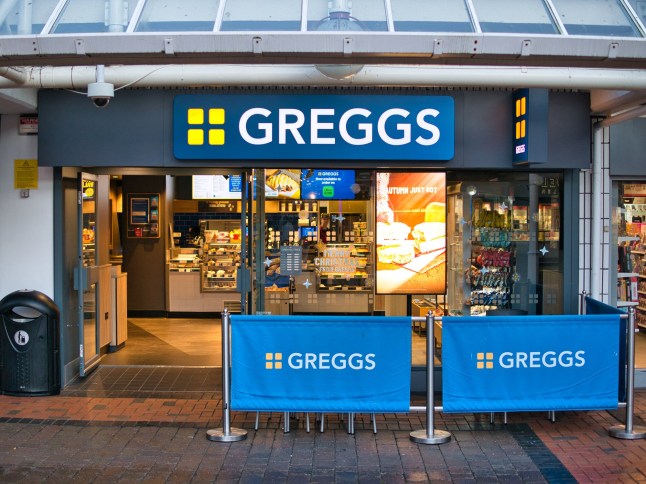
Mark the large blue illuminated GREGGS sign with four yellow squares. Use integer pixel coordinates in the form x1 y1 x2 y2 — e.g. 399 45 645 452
173 94 455 161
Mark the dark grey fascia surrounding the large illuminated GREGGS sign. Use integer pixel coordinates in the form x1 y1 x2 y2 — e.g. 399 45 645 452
38 89 590 170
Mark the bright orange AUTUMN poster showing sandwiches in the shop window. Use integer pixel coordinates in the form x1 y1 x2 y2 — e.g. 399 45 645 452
375 172 446 294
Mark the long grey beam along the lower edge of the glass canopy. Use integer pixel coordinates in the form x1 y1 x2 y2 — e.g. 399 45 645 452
5 32 646 67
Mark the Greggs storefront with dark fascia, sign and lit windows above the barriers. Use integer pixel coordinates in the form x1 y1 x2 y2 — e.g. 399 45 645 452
38 87 591 382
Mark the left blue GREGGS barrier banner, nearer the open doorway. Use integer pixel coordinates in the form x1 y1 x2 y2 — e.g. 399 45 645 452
231 315 411 412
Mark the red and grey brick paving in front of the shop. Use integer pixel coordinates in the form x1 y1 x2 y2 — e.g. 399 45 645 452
0 367 646 483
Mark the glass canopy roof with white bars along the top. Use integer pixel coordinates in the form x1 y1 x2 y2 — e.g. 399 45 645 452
0 0 646 38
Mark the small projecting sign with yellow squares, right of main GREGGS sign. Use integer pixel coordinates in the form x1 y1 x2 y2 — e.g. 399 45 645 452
513 89 549 165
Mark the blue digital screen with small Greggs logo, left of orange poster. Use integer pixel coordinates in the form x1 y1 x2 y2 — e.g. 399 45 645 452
301 170 361 200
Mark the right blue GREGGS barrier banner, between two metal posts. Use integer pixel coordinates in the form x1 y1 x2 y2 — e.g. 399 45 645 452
442 315 619 412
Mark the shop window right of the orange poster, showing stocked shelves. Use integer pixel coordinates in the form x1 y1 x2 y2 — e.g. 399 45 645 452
447 174 563 316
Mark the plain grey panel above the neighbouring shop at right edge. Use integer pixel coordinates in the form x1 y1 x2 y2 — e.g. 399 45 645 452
610 118 646 178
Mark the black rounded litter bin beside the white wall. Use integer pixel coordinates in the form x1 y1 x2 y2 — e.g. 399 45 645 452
0 290 61 396
